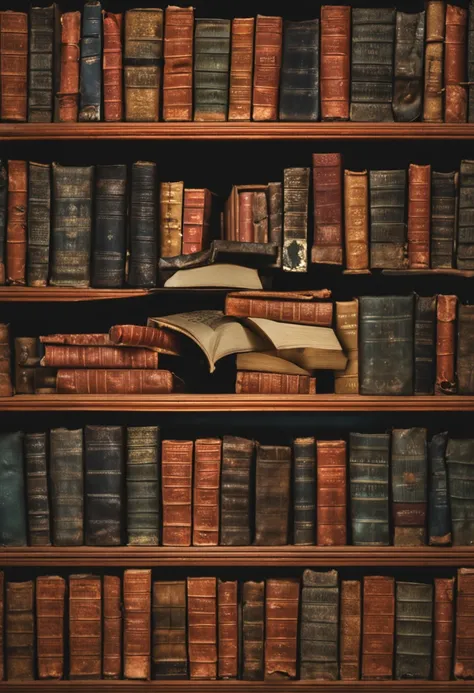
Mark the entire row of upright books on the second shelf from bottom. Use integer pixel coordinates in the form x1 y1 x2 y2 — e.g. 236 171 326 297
0 426 474 546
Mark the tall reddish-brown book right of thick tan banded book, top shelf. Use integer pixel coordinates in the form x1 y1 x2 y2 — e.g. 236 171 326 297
163 5 194 121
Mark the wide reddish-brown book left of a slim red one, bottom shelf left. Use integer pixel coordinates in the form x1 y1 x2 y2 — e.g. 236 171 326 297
69 575 102 681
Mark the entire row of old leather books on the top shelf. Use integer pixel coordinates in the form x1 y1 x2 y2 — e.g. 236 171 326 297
5 0 474 123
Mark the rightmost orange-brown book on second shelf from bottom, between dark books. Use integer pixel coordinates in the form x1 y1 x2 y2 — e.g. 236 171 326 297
316 440 347 546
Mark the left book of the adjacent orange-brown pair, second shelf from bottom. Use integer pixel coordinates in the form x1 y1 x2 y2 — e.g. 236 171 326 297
161 440 193 546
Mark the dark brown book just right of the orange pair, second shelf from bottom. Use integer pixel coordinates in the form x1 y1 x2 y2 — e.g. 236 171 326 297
220 436 255 546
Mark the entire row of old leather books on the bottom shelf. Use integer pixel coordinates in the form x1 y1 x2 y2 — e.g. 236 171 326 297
0 568 474 685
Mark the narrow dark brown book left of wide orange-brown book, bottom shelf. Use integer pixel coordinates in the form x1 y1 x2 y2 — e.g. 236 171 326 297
242 582 265 681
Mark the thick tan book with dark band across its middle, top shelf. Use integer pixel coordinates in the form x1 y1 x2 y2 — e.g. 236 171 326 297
123 7 163 122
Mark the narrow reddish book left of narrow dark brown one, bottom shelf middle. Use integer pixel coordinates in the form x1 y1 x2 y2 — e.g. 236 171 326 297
217 580 239 679
